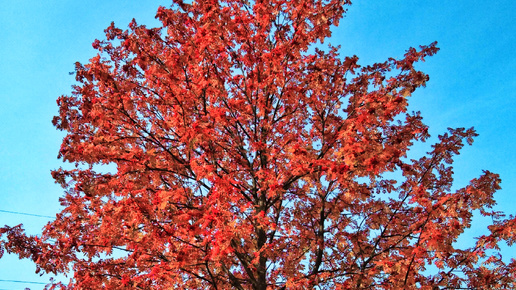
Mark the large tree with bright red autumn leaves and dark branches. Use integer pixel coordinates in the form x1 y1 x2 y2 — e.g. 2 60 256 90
0 0 516 289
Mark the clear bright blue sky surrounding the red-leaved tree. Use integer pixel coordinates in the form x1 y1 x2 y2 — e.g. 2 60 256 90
0 0 516 289
